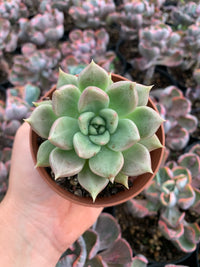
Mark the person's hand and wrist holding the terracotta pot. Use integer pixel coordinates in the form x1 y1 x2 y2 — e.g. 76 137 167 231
0 123 102 267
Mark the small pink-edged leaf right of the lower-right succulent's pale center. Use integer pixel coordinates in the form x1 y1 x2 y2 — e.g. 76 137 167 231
178 184 195 210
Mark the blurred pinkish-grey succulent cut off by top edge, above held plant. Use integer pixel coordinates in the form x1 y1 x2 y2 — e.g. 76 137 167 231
69 0 115 29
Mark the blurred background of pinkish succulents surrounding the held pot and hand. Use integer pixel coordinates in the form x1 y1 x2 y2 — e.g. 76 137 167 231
0 0 200 267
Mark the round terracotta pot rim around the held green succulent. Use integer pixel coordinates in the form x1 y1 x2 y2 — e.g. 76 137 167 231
30 74 165 207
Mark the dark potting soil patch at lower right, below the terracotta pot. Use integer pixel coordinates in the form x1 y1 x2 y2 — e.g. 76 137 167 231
115 204 186 263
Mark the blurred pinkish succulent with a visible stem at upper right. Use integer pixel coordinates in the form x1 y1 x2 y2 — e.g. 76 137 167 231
131 23 183 83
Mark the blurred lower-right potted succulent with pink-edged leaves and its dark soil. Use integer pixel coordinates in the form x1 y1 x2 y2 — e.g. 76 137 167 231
116 164 200 266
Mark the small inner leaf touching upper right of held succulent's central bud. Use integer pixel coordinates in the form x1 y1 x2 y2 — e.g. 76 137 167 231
99 108 118 134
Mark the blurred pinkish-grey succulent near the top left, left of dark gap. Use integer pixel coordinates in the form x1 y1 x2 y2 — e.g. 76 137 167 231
19 5 64 45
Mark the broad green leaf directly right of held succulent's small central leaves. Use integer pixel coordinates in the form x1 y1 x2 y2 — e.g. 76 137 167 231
108 119 140 151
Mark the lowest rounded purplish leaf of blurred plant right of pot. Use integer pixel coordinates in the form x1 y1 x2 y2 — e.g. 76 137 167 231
166 125 190 151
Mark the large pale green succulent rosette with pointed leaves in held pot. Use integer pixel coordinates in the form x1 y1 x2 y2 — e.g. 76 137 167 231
26 61 163 201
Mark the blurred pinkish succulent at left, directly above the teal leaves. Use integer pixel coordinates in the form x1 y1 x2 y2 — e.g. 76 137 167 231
9 43 61 90
